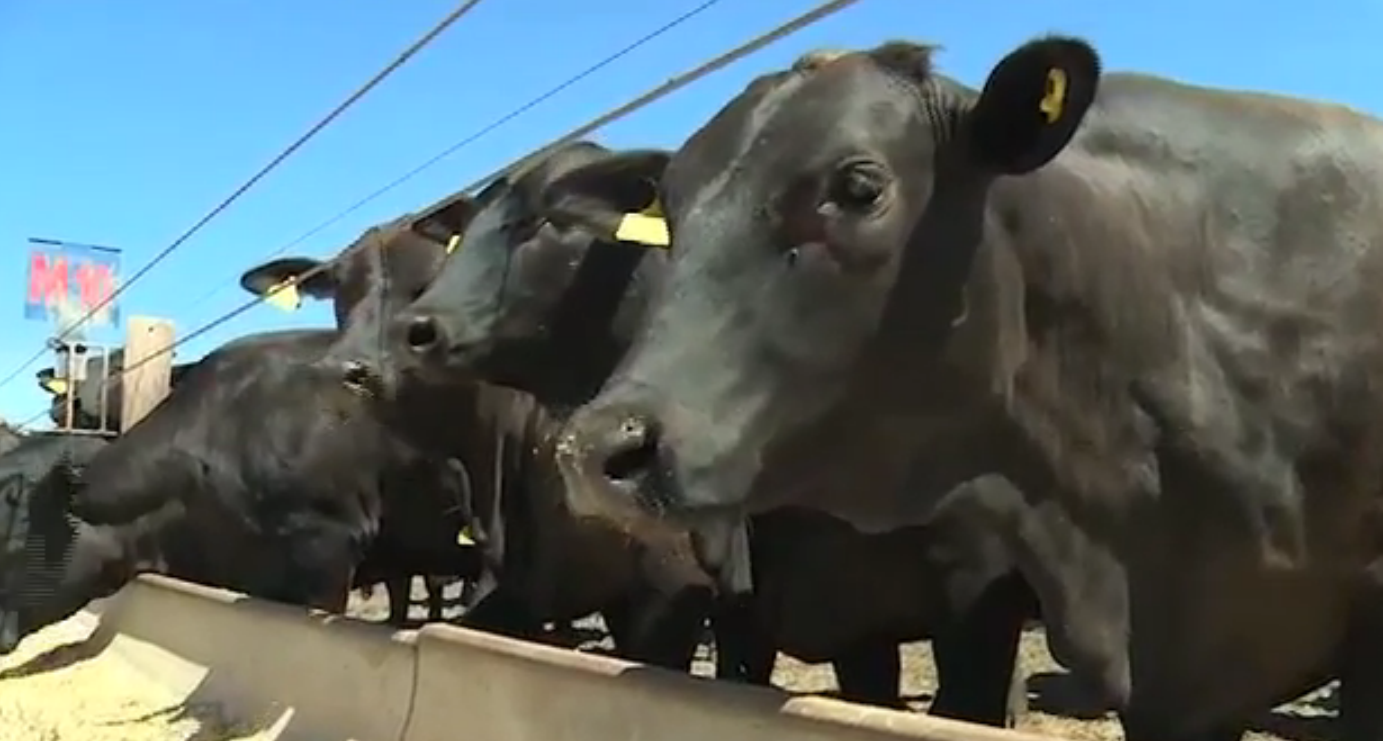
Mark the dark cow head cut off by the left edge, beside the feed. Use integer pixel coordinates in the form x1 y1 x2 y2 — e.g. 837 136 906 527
0 435 121 655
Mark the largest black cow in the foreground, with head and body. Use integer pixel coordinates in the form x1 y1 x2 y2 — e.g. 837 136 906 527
560 36 1383 741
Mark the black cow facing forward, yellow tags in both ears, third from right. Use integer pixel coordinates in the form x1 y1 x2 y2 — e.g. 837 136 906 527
242 183 712 669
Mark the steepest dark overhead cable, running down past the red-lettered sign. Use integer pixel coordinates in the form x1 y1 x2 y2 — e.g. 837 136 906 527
0 0 492 387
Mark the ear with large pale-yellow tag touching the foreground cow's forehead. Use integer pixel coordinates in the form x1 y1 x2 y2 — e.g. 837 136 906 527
542 149 672 247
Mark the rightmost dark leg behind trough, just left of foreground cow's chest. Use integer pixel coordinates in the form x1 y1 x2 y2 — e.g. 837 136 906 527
931 575 1036 727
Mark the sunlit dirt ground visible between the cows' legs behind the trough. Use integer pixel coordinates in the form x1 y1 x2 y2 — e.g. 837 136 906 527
349 581 1335 741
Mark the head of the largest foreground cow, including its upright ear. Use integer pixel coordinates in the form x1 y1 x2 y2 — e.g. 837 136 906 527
560 39 1099 575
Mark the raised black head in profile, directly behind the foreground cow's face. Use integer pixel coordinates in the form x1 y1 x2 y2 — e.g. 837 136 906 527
390 142 669 402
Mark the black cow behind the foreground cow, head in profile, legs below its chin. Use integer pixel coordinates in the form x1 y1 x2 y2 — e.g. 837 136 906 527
329 137 1033 723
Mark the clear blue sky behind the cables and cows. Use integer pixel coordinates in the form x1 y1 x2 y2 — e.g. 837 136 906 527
0 0 1383 422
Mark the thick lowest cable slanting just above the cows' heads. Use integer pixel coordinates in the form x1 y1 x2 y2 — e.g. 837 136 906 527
33 0 859 419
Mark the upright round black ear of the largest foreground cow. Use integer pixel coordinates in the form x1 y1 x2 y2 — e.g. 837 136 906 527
967 36 1099 174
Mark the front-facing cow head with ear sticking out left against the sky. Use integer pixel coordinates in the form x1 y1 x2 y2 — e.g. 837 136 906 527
241 196 474 390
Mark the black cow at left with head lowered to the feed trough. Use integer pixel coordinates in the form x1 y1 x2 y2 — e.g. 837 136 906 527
0 330 476 655
